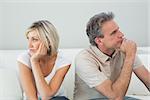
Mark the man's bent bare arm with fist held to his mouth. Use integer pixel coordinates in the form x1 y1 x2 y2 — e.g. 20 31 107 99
95 40 136 100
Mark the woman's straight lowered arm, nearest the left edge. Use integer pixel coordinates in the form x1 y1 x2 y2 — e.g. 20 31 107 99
18 62 38 100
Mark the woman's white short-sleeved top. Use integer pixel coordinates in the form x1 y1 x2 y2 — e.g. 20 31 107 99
17 51 71 98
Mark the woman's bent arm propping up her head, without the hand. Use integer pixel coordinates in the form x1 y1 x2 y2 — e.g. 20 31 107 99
31 61 70 100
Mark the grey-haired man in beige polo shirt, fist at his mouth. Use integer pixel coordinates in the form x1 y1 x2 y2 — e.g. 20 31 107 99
75 12 150 100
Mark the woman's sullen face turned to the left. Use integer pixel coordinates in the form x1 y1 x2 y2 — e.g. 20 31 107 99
27 30 41 56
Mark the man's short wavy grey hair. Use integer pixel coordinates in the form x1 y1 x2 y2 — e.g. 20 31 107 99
86 12 114 46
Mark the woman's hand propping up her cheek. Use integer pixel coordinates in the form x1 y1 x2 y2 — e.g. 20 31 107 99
31 42 47 62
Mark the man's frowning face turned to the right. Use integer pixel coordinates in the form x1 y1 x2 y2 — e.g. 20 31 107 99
101 20 124 49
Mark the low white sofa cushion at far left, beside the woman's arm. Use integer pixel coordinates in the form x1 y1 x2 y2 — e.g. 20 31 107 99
0 68 22 100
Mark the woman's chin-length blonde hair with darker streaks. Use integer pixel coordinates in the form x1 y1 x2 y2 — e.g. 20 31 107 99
26 20 59 55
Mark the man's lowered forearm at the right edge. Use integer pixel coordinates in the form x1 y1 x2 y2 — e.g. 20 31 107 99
133 65 150 91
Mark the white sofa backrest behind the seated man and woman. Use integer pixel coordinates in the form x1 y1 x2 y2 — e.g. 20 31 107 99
0 48 150 100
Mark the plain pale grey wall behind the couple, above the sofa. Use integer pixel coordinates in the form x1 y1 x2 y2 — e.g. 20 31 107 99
0 0 150 49
